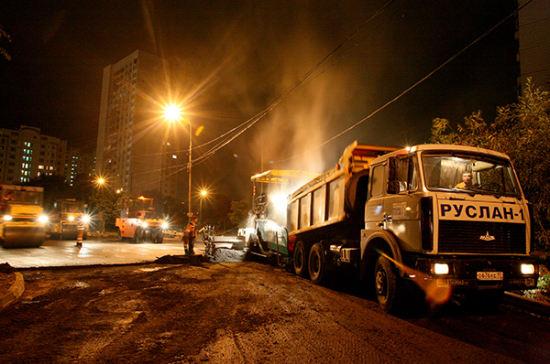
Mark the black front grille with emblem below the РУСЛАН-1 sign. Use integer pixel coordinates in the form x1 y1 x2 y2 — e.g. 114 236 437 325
439 221 527 254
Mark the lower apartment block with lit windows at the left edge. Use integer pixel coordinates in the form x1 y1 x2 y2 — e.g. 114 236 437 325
0 125 67 184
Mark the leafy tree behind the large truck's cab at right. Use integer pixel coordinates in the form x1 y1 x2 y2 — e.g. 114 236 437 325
431 79 550 251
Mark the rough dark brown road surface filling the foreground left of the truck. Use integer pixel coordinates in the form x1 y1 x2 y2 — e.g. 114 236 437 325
0 253 548 364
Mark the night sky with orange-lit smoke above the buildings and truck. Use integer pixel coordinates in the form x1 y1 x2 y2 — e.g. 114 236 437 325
0 0 517 199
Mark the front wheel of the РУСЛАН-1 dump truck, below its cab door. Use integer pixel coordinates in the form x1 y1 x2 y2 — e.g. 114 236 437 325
374 256 398 312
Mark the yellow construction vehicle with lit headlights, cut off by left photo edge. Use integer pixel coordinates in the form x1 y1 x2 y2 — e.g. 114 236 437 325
0 185 48 248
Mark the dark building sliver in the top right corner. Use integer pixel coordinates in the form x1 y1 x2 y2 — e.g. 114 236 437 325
516 0 550 90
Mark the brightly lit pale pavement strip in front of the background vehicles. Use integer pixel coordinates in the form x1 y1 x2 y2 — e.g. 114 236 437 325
0 237 204 268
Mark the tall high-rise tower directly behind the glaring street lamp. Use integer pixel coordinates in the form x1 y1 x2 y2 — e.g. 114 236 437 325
96 50 181 197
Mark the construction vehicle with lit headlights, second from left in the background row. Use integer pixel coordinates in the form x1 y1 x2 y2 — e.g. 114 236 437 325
46 199 90 240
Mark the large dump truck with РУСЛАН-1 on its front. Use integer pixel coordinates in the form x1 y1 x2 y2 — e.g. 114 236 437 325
247 142 539 313
